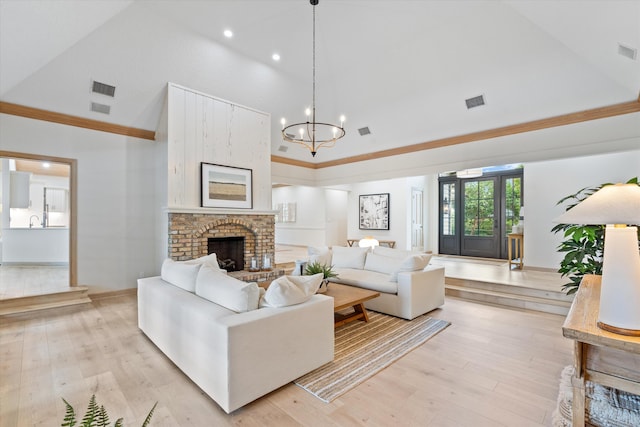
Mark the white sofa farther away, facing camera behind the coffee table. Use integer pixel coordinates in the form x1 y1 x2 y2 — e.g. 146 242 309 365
309 246 444 320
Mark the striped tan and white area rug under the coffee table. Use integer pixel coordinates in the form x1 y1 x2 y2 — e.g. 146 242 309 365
294 312 450 403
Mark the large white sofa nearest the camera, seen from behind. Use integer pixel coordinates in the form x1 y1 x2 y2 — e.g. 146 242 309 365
138 261 334 413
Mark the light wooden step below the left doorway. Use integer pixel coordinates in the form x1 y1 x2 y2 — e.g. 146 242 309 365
0 286 91 316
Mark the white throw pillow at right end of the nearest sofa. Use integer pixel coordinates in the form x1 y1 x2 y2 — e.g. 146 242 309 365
260 273 324 307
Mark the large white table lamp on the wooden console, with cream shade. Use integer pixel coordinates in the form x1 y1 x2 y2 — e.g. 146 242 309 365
554 184 640 336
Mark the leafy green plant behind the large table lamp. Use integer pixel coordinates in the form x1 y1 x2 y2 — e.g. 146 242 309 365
551 177 638 295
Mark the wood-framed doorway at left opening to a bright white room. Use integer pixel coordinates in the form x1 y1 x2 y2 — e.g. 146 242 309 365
0 150 77 298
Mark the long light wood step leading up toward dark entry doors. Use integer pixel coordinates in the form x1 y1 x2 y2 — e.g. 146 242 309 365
445 284 571 316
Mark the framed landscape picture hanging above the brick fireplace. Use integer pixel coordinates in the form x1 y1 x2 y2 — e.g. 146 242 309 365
200 162 253 209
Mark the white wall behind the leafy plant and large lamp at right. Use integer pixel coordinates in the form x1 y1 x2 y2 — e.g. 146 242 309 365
524 150 640 269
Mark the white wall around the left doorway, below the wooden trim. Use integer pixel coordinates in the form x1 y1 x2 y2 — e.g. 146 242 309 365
0 114 158 292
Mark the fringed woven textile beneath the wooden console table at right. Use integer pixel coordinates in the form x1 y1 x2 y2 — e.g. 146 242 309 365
551 366 640 427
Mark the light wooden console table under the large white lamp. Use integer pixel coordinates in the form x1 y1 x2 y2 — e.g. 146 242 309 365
562 275 640 427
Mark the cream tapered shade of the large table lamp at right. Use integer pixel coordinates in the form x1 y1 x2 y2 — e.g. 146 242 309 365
554 184 640 225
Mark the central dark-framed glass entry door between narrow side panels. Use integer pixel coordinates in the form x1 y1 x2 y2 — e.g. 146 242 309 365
460 177 501 258
